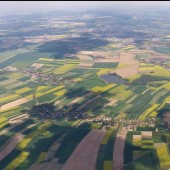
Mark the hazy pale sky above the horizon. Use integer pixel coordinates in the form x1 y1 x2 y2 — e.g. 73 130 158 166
0 1 170 15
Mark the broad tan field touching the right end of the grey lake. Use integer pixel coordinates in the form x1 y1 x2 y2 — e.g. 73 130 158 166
115 65 139 78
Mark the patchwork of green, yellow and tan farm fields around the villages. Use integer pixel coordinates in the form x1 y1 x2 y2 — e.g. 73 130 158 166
0 35 170 170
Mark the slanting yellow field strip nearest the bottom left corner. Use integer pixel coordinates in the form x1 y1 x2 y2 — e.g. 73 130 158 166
4 152 29 170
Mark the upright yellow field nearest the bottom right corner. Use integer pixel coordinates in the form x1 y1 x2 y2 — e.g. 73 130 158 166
156 144 170 167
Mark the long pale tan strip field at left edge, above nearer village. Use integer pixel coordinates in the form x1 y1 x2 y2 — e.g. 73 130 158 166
0 98 29 111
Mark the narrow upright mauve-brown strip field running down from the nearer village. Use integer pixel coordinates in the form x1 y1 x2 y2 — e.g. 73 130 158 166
113 132 126 170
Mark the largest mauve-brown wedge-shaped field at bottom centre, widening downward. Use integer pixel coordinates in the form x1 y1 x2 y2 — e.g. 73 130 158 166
61 130 106 170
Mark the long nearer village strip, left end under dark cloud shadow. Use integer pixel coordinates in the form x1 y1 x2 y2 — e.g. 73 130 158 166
9 100 170 131
